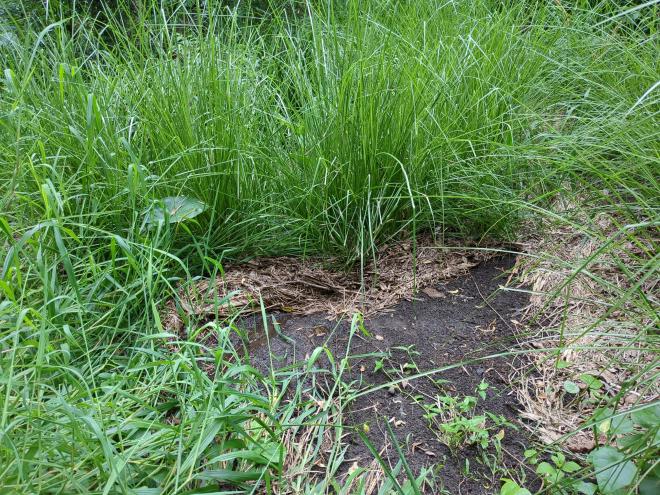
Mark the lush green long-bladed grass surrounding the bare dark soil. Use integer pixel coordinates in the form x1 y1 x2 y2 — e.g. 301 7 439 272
0 0 660 493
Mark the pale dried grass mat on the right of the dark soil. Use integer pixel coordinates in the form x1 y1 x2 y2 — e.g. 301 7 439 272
511 215 660 452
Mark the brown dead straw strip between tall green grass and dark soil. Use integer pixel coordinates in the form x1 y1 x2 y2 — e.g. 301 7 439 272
163 236 494 333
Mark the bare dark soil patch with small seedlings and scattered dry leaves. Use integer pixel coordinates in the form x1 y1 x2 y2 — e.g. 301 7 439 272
241 257 533 494
